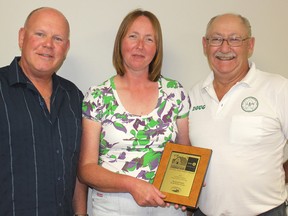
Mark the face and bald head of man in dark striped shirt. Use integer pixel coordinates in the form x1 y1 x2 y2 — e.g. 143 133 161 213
19 9 70 76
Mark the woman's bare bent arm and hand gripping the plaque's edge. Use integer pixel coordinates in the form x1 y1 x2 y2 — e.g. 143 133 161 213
78 118 165 206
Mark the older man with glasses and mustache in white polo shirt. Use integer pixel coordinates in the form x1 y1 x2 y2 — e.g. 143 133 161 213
189 14 288 216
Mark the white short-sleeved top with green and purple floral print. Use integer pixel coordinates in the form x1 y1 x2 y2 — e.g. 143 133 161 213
82 77 190 183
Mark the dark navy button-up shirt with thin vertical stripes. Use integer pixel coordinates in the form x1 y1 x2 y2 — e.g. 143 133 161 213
0 57 83 216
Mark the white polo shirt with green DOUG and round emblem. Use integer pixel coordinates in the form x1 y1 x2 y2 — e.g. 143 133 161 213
189 63 288 216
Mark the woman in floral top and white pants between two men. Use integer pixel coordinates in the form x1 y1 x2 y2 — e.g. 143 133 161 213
79 10 190 216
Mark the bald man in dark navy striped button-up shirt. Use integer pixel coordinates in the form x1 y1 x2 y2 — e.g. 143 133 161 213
0 8 86 216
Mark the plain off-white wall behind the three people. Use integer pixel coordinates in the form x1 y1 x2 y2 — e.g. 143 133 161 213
0 0 288 213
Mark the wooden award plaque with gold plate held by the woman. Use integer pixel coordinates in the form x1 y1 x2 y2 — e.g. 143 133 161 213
153 143 212 208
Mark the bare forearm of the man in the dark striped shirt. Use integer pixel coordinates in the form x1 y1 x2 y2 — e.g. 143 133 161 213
73 178 88 216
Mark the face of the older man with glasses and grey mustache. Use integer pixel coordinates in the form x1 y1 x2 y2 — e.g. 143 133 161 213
202 14 254 76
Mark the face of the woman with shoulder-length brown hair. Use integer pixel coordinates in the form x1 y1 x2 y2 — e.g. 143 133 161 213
121 16 157 73
